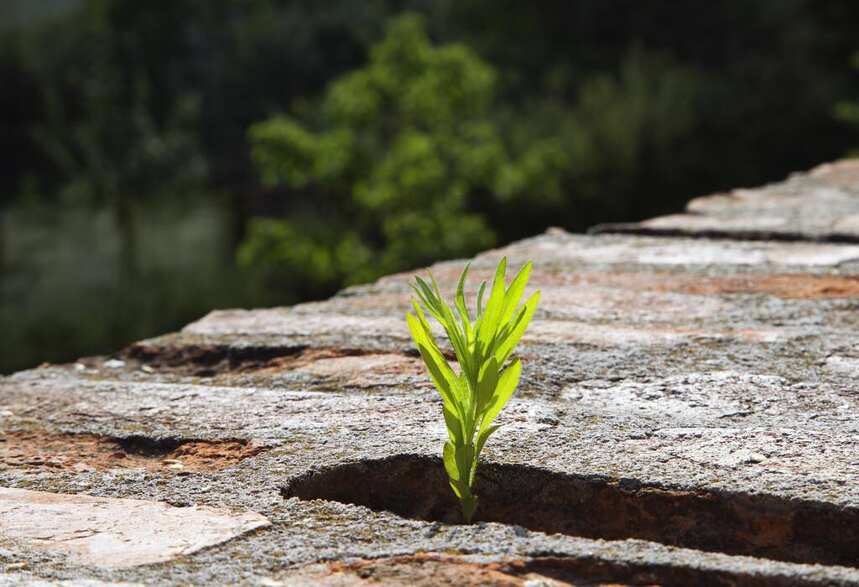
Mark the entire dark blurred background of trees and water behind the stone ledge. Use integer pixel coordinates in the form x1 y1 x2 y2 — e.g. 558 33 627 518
0 0 859 373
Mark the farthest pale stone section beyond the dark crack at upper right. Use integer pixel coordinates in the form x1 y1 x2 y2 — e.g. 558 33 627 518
592 159 859 243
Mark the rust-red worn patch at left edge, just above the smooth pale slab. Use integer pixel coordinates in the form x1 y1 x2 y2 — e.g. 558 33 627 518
0 431 262 473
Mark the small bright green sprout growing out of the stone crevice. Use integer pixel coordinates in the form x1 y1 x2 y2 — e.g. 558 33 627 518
406 257 540 522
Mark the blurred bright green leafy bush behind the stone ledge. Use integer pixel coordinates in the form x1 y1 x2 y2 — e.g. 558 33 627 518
239 15 567 294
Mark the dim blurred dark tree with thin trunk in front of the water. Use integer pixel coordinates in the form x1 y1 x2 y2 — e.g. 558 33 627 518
17 2 206 277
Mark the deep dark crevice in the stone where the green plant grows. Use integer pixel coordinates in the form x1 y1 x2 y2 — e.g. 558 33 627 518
281 454 859 567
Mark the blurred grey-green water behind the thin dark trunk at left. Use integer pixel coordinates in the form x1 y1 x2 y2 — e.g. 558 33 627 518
0 194 255 373
